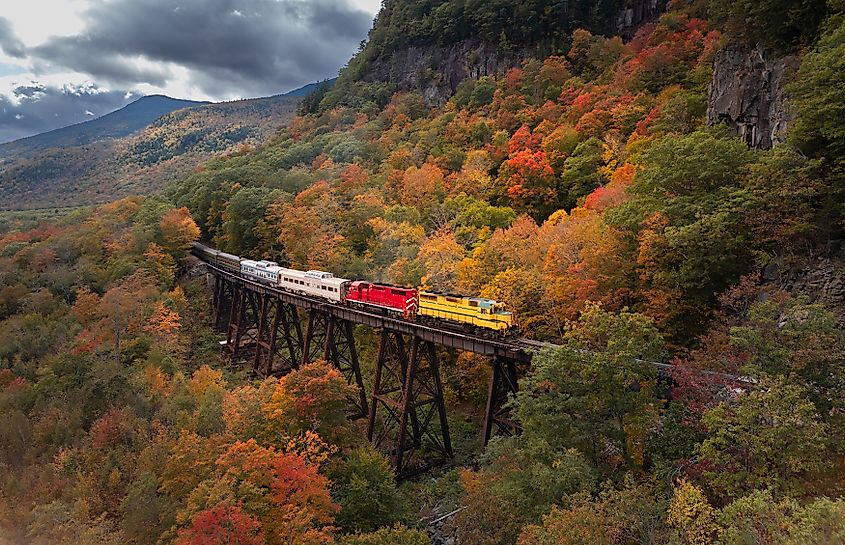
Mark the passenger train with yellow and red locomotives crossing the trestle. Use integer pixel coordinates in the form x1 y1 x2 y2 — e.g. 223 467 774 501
193 242 516 335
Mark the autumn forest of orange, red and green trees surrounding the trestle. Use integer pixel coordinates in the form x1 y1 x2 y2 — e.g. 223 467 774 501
0 0 845 545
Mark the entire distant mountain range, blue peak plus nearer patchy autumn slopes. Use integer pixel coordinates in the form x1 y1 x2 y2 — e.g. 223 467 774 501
0 92 307 210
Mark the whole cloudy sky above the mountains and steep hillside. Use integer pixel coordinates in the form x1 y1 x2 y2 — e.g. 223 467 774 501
0 0 380 142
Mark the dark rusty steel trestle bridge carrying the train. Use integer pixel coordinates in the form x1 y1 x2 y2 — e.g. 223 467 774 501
192 251 692 478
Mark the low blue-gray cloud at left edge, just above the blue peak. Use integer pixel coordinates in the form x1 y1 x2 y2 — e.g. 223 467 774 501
0 85 138 143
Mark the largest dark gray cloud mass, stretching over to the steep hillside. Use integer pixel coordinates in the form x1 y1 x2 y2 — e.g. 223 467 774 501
28 0 372 97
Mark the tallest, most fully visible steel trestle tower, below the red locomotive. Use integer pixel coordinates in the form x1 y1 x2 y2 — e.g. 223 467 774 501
367 328 452 478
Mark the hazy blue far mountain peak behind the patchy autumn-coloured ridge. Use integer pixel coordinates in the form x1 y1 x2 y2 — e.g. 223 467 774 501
0 95 208 160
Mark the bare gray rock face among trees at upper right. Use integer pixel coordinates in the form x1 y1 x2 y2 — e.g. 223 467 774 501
707 44 797 149
